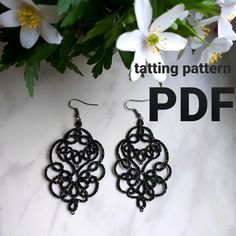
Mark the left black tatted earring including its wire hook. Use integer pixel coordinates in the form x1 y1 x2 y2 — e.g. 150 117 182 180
45 99 105 214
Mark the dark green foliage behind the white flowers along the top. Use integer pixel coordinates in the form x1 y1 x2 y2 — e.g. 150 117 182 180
0 0 220 96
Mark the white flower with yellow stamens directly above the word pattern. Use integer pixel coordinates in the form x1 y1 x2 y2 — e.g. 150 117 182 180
199 38 233 64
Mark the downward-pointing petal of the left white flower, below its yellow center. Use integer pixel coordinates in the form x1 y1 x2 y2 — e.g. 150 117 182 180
20 28 39 49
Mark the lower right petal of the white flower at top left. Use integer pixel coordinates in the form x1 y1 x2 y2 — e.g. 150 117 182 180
38 20 62 44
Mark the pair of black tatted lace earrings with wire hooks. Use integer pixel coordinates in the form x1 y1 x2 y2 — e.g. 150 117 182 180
45 99 171 214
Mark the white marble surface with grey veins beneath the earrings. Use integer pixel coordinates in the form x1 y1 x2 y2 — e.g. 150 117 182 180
0 48 236 236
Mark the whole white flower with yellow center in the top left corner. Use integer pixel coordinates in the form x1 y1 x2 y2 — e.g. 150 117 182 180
0 0 62 48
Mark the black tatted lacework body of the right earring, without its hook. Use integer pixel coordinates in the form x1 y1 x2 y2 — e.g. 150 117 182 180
114 119 171 212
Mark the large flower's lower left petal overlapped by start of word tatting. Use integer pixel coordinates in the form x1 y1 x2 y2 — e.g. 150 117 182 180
130 46 148 81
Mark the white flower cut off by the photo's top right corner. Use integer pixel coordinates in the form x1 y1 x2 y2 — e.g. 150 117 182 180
217 0 236 41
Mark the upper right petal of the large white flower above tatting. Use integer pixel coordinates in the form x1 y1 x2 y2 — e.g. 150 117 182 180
150 4 184 33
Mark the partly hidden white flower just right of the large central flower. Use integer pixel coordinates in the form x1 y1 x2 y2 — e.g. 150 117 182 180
189 16 218 49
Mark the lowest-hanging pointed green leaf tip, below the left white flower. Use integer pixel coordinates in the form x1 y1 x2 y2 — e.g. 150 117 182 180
24 62 40 97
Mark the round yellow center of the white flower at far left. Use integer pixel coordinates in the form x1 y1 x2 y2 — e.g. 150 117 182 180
17 8 40 30
